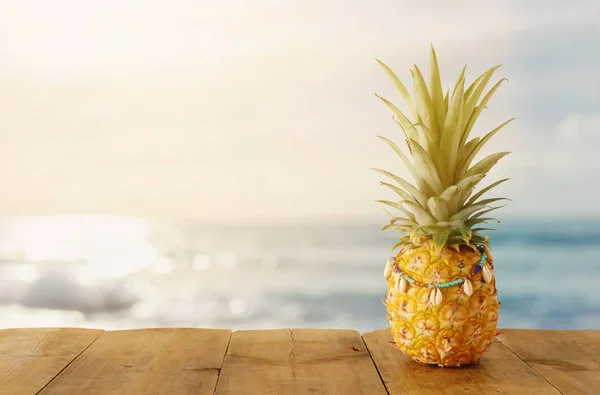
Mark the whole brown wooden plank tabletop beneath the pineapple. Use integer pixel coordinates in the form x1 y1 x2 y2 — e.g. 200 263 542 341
0 328 600 395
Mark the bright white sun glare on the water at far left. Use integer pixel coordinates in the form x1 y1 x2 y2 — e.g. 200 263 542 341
7 216 164 285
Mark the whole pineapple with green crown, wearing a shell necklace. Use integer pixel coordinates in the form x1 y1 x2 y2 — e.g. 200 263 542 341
373 46 514 366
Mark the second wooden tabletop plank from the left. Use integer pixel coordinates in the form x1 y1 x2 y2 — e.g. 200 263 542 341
41 328 231 395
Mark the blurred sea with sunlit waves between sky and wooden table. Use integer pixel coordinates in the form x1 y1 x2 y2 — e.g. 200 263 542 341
0 216 600 332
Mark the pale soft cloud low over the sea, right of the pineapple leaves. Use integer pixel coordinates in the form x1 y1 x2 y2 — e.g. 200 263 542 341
502 113 600 217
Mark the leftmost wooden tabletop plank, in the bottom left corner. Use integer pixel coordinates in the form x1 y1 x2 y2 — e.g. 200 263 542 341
0 328 103 395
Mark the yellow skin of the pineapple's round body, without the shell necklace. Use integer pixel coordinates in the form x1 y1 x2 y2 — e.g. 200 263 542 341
386 245 500 367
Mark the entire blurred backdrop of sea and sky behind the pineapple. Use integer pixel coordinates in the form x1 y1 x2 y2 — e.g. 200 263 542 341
0 0 600 331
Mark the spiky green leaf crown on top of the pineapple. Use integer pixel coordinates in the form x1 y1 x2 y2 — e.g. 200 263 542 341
373 46 514 252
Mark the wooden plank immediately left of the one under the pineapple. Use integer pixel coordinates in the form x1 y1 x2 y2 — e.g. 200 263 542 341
216 329 387 395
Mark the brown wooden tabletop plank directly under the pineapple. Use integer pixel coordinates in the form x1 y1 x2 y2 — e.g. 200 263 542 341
363 329 559 395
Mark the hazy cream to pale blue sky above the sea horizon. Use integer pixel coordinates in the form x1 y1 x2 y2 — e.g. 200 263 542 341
0 0 600 221
